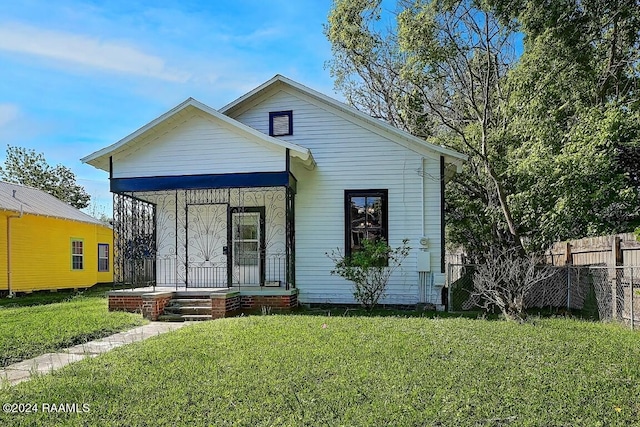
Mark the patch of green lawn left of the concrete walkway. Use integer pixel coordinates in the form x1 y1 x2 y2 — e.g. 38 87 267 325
0 289 143 366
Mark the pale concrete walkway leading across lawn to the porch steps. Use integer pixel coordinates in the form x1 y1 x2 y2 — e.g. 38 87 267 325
0 322 193 386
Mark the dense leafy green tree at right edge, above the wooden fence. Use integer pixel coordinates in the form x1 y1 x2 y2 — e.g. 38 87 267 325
500 0 640 249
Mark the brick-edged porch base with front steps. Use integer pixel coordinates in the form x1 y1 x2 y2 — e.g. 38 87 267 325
108 287 298 321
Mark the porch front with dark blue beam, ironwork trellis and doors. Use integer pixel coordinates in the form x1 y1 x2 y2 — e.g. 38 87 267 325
112 172 296 291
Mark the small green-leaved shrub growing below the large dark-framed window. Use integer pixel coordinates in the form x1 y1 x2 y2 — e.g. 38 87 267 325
327 239 411 310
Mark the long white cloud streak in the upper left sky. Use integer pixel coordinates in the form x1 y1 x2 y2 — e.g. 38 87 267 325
0 24 190 82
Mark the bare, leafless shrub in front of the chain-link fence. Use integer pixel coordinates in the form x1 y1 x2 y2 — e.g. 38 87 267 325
472 250 554 322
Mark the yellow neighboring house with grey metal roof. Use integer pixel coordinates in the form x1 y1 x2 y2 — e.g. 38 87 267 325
0 181 113 294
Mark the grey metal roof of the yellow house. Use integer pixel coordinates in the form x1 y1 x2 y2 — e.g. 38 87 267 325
0 181 106 226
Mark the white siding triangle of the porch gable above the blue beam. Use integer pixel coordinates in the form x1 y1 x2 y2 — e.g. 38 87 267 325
113 112 285 178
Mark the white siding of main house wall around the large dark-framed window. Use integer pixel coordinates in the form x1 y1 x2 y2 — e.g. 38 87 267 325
234 91 440 304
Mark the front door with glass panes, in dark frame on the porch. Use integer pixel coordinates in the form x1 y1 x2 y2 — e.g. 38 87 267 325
230 207 265 286
